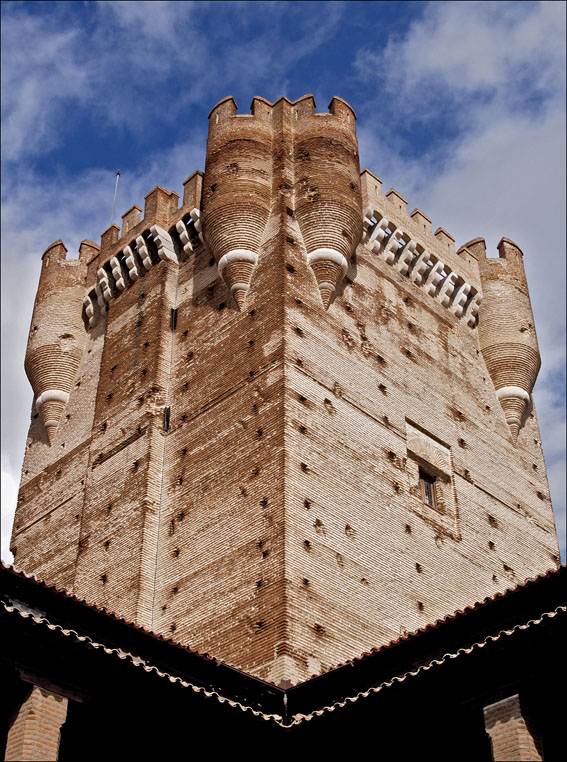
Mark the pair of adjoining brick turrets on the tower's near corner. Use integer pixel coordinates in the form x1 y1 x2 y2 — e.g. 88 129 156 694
202 95 362 308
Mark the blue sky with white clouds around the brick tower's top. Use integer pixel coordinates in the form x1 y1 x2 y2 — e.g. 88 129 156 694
2 0 566 560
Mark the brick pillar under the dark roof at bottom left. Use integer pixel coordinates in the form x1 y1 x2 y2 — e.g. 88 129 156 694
4 685 67 762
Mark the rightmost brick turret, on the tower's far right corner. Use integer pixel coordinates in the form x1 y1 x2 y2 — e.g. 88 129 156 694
478 238 541 443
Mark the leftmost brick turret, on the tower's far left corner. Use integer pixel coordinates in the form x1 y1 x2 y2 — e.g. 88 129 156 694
25 241 90 444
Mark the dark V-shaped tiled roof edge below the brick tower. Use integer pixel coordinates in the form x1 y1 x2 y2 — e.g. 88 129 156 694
2 563 567 727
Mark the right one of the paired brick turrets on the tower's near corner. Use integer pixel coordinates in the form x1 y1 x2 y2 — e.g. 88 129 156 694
294 96 362 307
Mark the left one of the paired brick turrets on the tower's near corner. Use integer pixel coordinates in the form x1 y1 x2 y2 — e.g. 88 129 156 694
202 96 272 308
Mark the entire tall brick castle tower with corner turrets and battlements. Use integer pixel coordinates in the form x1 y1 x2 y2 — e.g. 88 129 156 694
12 95 559 687
